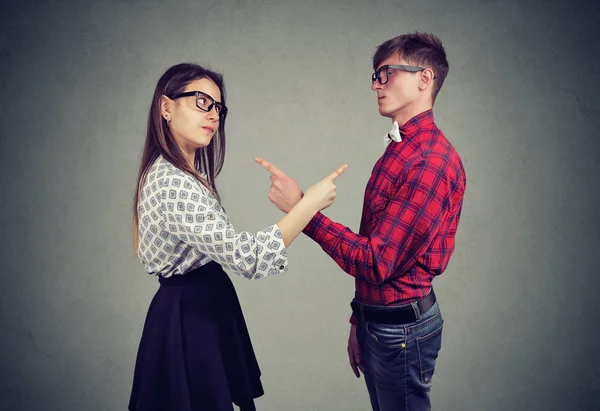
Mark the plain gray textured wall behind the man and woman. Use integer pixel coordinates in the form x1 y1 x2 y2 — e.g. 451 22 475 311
0 0 600 411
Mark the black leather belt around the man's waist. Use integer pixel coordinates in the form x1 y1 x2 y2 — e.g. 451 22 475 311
350 288 436 324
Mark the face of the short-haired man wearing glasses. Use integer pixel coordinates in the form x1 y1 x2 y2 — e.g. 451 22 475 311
371 55 422 119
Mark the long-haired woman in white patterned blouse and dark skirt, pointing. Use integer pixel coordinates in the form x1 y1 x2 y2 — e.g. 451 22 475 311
129 64 346 411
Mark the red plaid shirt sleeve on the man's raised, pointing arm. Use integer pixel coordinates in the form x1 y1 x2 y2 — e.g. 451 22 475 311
304 156 454 284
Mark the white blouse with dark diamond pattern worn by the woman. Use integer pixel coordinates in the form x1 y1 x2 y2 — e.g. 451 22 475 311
138 156 288 279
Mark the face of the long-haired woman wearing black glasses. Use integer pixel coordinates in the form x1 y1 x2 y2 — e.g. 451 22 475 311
162 78 221 158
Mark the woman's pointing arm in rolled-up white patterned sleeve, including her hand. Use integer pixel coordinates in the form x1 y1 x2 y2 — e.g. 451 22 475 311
151 164 343 279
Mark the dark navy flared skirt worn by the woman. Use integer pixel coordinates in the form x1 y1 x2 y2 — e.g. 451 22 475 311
129 262 264 411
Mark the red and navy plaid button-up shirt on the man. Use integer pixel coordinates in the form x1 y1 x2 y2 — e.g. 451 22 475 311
304 110 466 323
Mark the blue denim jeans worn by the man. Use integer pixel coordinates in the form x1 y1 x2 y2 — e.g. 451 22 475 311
356 302 444 411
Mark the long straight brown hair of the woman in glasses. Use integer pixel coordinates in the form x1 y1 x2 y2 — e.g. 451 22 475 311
133 63 226 255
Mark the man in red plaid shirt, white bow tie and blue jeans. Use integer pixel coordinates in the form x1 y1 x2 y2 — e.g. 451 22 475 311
256 33 466 411
